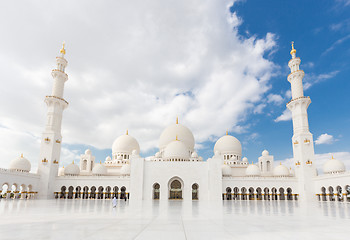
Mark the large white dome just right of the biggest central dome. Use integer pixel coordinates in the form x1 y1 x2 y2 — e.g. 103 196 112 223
214 135 242 156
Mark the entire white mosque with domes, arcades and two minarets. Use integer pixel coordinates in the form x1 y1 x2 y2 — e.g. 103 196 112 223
0 44 350 201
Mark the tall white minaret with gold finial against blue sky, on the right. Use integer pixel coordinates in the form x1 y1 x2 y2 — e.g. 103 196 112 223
287 42 315 200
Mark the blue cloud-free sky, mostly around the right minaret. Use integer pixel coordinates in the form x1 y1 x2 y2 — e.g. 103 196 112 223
76 0 350 161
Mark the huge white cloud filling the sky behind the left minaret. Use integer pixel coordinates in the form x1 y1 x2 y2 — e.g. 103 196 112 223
0 0 276 168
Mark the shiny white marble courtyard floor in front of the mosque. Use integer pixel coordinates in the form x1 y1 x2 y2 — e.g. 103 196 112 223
0 199 350 240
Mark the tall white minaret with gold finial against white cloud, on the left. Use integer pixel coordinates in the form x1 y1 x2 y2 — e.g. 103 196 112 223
38 43 68 198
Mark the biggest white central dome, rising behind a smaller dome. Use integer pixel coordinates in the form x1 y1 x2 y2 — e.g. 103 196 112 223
159 124 194 152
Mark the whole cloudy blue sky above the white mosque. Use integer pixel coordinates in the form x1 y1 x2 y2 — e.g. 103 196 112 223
0 0 350 172
